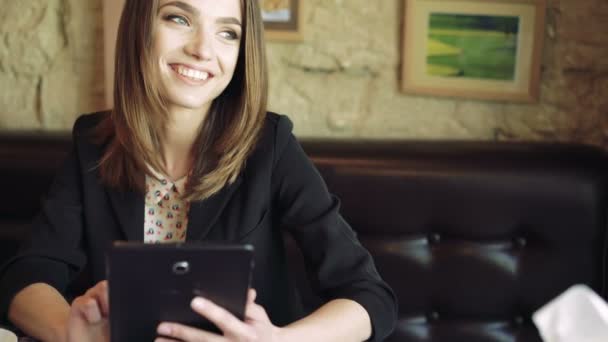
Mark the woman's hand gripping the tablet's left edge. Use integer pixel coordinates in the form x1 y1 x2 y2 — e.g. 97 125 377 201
66 280 110 342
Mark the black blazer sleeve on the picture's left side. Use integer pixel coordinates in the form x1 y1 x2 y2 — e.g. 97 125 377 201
0 119 86 321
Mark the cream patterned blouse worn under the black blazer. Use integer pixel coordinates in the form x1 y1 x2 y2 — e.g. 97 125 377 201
144 169 190 243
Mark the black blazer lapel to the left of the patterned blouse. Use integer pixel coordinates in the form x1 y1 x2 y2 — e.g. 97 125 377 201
108 190 144 242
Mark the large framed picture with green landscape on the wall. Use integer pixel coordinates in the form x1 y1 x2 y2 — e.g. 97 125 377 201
401 0 546 102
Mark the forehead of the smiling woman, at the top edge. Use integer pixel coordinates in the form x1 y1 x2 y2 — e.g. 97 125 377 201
158 0 242 20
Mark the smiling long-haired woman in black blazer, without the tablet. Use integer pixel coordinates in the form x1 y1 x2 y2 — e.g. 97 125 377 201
0 0 396 341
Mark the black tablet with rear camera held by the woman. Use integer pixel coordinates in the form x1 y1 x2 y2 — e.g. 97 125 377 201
107 242 253 342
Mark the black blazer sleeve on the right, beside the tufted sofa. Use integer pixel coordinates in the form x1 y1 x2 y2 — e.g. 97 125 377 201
273 116 397 341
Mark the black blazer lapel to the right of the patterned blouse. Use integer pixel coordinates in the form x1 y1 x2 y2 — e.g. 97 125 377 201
186 176 241 241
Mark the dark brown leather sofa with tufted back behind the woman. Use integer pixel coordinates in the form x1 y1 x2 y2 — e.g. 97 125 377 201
0 133 608 342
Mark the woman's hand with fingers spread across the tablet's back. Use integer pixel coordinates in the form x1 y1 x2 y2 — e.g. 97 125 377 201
155 289 281 342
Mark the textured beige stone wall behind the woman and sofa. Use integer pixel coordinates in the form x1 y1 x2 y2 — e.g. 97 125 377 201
0 0 608 145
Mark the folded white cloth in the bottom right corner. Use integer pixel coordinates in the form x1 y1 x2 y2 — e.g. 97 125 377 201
532 285 608 342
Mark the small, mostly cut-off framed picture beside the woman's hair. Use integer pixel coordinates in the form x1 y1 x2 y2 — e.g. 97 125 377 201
260 0 302 41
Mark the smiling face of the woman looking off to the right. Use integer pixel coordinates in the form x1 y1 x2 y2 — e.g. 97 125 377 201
153 0 243 112
